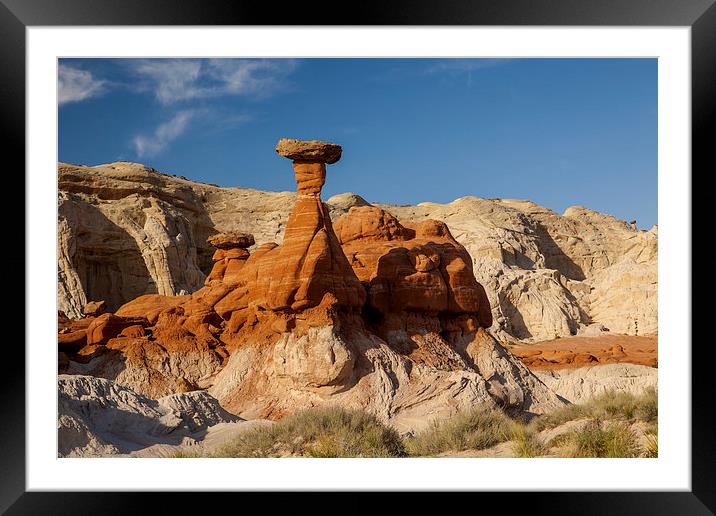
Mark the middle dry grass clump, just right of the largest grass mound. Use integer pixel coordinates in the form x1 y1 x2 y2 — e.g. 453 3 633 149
405 407 514 456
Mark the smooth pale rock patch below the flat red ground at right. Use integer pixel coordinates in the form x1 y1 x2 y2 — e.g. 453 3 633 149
535 364 659 403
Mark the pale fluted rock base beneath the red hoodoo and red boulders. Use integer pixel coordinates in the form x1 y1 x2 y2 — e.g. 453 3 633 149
209 326 562 432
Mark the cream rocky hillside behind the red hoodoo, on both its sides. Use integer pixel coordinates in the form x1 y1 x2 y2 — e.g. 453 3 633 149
58 162 658 341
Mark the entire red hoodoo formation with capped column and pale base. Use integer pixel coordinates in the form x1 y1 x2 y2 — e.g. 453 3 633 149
61 139 562 430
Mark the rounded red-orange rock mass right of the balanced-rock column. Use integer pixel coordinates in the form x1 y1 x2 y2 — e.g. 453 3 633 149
336 206 492 331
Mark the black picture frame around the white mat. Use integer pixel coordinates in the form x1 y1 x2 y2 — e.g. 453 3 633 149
0 0 716 514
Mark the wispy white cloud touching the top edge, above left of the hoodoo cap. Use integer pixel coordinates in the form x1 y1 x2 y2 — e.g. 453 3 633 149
130 59 297 104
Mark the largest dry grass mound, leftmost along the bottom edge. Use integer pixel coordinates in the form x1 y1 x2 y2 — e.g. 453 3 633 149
212 407 405 457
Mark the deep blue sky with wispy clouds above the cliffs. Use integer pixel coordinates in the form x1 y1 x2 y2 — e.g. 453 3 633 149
58 59 657 229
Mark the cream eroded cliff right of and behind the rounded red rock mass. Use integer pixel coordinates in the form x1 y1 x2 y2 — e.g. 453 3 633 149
381 197 658 342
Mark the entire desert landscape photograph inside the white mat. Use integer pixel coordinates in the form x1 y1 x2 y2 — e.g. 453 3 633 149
58 58 656 464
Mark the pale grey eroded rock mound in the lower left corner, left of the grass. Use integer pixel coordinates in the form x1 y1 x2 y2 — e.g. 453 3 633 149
57 375 241 457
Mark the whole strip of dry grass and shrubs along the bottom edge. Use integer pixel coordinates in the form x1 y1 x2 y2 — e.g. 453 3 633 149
170 390 658 458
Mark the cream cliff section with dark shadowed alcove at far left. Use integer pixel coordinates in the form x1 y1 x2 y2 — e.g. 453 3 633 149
58 162 209 317
